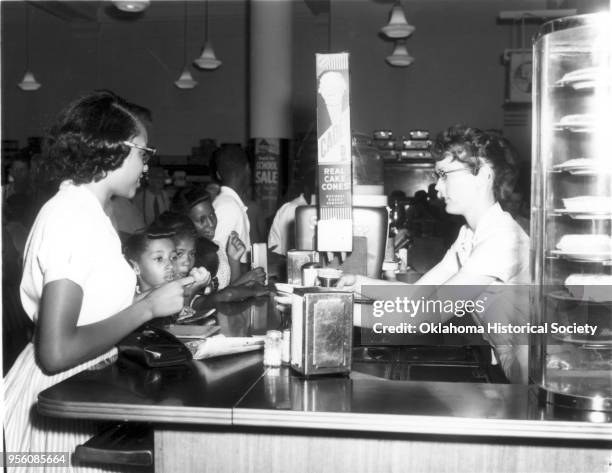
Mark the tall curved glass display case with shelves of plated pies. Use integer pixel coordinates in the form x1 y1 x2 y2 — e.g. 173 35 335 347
530 13 612 411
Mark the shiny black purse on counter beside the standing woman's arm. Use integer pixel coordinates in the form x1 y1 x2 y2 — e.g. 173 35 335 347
117 324 192 368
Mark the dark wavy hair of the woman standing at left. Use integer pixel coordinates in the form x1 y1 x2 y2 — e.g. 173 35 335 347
44 91 144 184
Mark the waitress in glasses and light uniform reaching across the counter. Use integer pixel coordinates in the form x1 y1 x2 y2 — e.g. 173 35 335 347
338 125 530 383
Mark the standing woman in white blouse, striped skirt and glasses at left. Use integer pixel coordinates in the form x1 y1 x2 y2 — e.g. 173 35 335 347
4 92 192 472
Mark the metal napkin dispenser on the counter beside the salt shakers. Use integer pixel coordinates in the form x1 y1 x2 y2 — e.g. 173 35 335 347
291 287 353 376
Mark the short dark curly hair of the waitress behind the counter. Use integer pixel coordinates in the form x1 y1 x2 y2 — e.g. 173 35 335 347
432 125 518 202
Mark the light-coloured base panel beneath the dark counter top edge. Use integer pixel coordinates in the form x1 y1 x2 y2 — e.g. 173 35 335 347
155 428 612 473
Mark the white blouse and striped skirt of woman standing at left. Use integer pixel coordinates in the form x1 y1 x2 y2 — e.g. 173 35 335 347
4 182 136 473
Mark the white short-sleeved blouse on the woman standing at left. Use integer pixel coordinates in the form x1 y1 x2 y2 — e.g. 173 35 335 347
21 182 136 325
